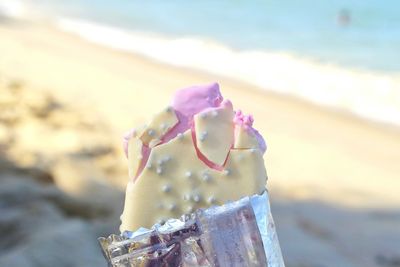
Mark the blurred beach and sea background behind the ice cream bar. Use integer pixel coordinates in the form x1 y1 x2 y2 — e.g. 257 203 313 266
0 0 400 267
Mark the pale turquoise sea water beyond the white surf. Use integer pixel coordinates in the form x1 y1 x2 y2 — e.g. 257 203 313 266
19 0 400 71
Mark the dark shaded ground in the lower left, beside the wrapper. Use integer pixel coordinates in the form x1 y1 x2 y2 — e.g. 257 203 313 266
0 167 122 267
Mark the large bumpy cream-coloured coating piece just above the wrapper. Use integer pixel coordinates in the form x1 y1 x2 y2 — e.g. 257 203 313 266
120 130 267 232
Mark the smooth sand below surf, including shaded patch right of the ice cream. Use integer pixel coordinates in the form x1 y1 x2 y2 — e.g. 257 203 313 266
0 21 400 267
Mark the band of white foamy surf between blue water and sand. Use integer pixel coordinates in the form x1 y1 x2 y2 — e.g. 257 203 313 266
54 18 400 126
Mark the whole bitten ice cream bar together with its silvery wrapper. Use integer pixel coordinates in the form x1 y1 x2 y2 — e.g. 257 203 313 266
99 84 284 267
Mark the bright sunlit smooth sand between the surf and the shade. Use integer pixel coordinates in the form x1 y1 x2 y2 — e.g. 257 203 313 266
0 20 400 208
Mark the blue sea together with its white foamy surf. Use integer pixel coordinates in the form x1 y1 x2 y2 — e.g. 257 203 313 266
0 0 400 125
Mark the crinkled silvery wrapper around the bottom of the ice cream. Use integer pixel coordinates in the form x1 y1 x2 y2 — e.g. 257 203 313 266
98 191 285 267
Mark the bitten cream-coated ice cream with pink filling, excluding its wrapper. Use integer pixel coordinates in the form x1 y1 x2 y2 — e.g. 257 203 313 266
120 84 267 232
